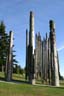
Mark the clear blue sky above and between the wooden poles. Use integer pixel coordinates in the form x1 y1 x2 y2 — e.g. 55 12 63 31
0 0 64 76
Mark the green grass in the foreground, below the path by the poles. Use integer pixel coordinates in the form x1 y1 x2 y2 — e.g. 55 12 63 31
0 82 64 96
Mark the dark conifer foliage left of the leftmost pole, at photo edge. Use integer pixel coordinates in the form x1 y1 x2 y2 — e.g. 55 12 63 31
0 21 9 65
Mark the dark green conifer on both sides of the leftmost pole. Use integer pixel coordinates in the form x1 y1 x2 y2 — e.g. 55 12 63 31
0 21 18 73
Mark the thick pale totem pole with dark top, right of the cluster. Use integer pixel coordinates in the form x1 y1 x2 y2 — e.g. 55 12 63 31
50 20 59 86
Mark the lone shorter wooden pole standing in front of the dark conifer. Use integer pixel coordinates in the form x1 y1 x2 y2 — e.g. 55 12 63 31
6 31 13 81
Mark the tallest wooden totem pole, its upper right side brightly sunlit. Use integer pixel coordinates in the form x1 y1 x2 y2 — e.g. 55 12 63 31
28 11 35 84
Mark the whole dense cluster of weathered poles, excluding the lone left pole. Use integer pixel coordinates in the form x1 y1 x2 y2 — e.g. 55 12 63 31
26 11 59 86
